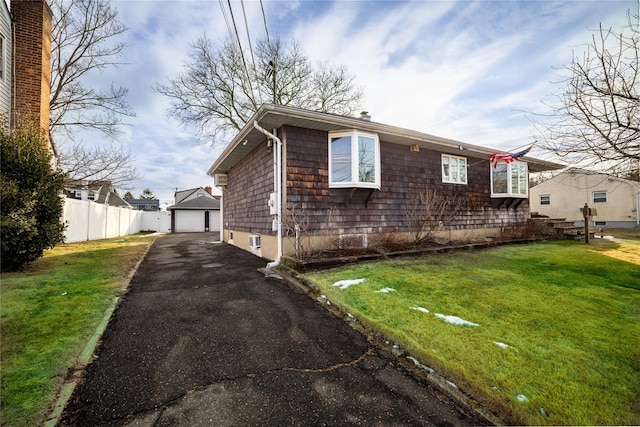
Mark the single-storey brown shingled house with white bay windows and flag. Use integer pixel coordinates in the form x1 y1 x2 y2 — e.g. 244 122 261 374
208 105 562 260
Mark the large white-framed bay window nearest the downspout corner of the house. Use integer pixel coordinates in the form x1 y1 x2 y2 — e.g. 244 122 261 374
329 130 380 189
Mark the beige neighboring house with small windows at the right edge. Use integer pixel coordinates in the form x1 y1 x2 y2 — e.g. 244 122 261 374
530 168 640 227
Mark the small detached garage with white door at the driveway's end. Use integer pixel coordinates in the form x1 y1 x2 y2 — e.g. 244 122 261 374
167 197 220 233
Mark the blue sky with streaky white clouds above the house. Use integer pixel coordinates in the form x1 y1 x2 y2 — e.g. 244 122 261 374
67 0 638 206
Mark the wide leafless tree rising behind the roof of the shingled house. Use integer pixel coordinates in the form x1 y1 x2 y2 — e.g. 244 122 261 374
155 36 362 140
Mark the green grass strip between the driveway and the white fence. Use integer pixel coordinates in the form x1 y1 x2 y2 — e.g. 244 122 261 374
0 235 157 426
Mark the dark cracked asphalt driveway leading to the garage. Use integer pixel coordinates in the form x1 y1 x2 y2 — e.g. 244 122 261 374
60 233 478 426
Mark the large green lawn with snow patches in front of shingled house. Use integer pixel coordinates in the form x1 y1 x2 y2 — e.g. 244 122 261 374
308 238 640 425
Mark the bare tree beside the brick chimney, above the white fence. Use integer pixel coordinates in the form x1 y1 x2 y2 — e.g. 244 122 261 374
49 0 140 186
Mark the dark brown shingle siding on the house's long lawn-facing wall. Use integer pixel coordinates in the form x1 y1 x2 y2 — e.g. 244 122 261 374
285 127 528 233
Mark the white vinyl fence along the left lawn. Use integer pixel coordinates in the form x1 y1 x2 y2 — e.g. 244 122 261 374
62 198 171 243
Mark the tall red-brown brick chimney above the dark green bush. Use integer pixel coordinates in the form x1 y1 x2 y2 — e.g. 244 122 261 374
11 0 52 129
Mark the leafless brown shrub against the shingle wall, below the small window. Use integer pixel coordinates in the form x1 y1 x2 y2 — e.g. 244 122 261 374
405 189 464 244
